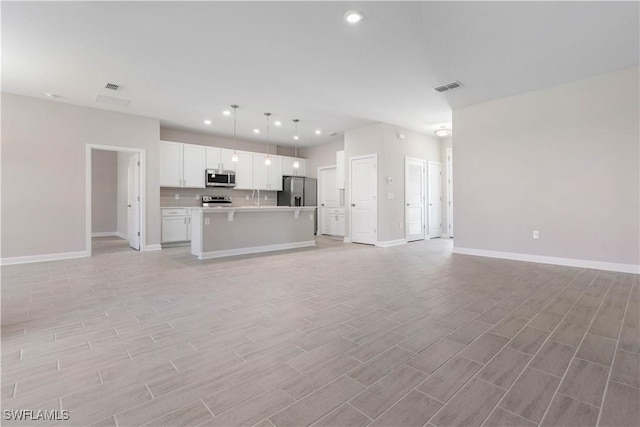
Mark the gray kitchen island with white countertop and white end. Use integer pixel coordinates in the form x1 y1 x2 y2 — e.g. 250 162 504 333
191 206 316 259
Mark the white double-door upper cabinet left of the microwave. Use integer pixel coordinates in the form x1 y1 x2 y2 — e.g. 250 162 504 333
160 141 206 188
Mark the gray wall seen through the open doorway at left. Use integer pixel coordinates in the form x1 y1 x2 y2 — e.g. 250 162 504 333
91 150 118 233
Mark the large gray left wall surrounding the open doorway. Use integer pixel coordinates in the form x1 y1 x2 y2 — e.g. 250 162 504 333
2 93 160 258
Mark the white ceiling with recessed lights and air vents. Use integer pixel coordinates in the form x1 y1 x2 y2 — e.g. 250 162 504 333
2 1 640 145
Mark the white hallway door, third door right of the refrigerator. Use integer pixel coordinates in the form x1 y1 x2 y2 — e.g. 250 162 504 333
404 158 425 242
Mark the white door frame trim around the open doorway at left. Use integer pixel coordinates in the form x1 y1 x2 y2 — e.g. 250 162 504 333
84 144 147 257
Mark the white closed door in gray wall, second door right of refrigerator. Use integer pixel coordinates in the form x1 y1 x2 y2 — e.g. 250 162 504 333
349 155 378 245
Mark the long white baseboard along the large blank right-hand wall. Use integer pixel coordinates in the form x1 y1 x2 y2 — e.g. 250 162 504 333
453 246 640 274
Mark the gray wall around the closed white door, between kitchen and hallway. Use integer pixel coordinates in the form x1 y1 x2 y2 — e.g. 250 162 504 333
344 123 441 242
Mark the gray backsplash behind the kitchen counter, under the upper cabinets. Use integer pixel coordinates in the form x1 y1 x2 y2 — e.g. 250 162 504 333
160 187 278 208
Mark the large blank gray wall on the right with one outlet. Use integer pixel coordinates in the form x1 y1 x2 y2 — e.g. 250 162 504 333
453 67 640 265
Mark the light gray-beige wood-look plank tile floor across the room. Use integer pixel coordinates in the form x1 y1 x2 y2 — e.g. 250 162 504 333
1 238 640 427
